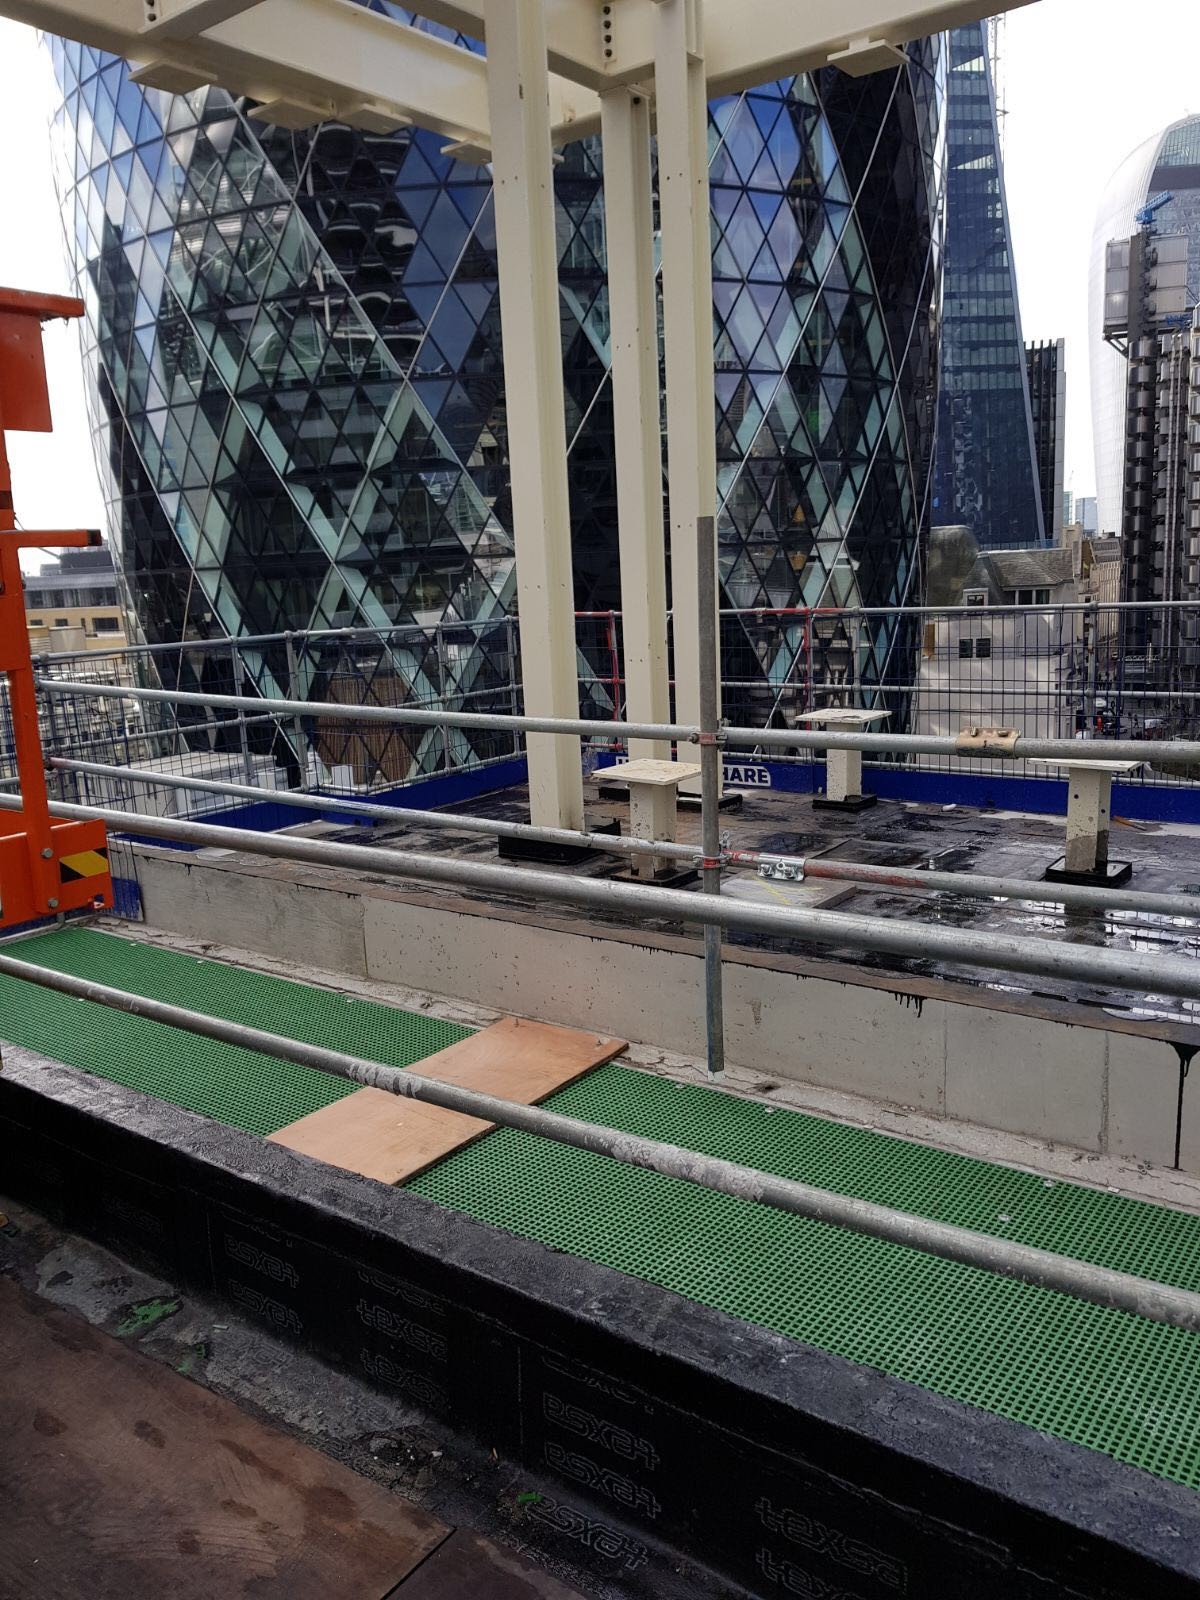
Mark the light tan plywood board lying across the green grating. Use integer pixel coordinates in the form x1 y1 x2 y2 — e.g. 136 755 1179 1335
269 1018 626 1184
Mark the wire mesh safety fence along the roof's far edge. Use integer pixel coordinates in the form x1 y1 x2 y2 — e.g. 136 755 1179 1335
14 602 1200 800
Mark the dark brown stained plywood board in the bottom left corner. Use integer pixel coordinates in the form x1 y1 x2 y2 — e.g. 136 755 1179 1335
0 1280 450 1600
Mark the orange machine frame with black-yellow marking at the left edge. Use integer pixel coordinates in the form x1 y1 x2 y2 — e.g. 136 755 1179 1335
0 288 112 930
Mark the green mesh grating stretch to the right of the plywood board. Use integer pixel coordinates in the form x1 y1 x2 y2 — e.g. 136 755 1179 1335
408 1066 1200 1488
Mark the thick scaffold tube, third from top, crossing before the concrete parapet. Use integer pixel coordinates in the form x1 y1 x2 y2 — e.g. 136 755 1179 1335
0 795 1200 1000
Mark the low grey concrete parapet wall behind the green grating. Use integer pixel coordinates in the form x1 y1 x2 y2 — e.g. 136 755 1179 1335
129 846 1200 1173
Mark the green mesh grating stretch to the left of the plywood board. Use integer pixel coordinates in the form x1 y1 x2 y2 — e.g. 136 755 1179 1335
0 928 470 1133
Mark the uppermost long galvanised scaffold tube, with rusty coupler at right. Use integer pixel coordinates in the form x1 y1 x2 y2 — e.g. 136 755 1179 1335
35 677 1200 765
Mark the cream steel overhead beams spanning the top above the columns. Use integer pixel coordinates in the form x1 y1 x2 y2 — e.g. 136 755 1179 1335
0 0 1032 140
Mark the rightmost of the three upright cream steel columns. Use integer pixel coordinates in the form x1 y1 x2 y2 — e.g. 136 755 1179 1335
654 0 717 790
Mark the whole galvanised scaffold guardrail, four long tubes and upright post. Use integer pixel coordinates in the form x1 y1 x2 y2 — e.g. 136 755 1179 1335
11 518 1200 1331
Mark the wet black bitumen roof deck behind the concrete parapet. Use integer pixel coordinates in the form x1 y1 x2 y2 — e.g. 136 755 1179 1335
302 787 1200 1022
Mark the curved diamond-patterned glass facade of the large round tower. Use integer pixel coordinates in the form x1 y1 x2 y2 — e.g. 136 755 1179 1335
50 28 942 764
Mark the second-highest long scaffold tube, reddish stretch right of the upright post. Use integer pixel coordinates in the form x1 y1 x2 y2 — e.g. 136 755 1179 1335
50 755 1200 920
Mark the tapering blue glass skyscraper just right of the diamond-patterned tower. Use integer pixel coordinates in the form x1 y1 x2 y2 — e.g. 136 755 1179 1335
933 22 1046 549
